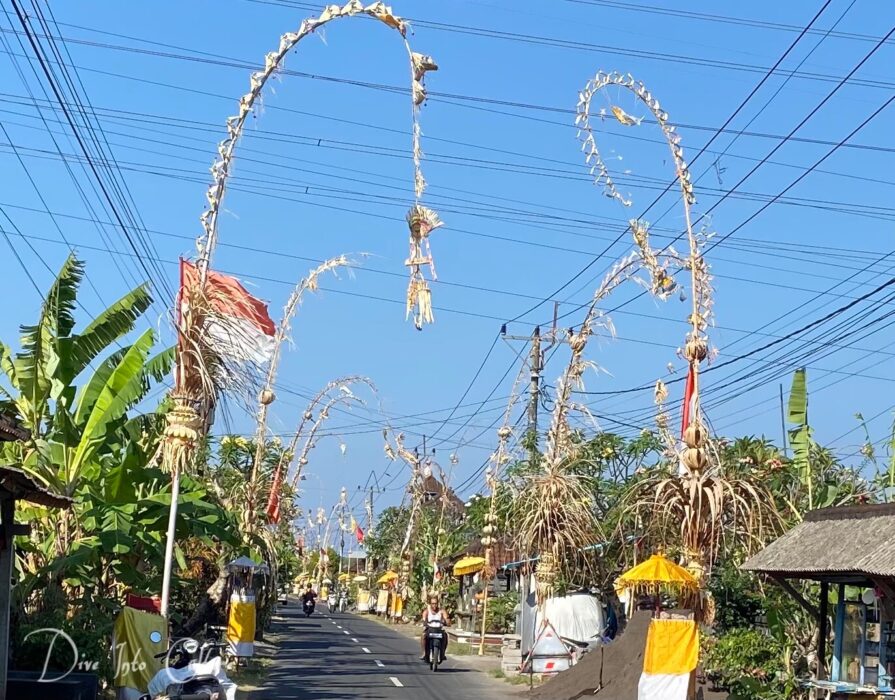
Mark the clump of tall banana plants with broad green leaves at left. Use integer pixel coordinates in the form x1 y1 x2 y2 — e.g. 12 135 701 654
0 256 237 680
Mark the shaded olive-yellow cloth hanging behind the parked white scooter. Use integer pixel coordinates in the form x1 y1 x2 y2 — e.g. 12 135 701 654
114 608 168 691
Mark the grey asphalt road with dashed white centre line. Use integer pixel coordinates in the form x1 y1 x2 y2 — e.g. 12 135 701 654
253 601 518 700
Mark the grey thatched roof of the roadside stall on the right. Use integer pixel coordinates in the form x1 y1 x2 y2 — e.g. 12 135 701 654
742 503 895 584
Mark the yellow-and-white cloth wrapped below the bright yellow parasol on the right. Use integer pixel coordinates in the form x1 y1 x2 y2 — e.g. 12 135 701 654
637 620 699 700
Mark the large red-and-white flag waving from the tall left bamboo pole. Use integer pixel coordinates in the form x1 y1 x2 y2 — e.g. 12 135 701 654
180 260 276 365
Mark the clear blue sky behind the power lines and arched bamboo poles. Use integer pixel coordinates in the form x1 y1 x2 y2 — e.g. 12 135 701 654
0 0 895 512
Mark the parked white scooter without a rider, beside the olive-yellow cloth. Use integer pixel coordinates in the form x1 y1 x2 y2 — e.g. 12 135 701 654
140 638 236 700
